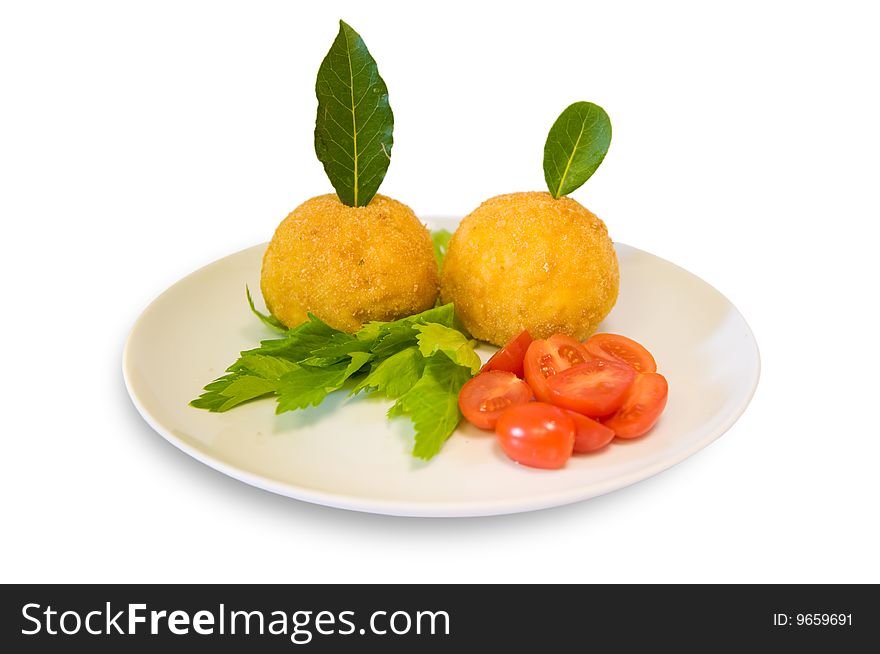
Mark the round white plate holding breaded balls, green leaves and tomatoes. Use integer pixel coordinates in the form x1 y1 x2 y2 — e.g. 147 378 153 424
123 220 760 517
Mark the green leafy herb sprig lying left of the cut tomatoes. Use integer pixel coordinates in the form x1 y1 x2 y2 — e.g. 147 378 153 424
190 291 480 459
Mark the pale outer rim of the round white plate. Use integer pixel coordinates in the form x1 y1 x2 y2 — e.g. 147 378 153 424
122 240 761 518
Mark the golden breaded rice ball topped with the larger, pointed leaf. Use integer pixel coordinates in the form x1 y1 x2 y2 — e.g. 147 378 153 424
260 194 439 333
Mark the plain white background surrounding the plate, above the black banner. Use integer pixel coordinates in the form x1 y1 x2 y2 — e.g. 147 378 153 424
0 0 880 582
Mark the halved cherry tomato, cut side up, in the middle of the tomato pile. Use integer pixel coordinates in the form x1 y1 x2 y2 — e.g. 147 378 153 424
536 359 636 418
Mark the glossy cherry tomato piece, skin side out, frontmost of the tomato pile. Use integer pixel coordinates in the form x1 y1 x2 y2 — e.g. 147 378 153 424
495 402 575 468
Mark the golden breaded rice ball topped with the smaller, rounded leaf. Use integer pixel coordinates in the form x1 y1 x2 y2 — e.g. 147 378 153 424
440 192 620 346
